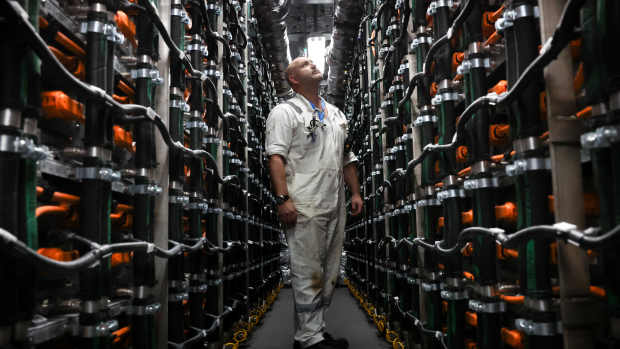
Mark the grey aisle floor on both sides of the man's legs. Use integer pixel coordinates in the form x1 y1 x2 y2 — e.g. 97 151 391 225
247 287 391 349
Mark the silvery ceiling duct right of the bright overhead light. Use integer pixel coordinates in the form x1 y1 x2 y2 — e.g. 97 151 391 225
327 0 362 109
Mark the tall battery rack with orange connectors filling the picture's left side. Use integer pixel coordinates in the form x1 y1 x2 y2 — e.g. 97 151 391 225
0 0 282 348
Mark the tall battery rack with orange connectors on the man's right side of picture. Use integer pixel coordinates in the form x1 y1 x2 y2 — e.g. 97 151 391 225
341 0 620 349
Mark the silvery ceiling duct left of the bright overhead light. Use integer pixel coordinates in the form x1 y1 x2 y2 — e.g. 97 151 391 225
254 0 291 97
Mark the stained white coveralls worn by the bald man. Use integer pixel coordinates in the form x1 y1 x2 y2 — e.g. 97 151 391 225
265 94 357 348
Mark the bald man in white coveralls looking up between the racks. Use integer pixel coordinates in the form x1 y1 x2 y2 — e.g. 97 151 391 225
265 57 363 349
